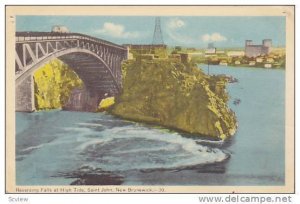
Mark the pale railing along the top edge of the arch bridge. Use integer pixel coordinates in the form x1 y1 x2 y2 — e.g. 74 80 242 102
16 32 127 51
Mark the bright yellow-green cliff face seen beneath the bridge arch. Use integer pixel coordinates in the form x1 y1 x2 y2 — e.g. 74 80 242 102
34 59 83 110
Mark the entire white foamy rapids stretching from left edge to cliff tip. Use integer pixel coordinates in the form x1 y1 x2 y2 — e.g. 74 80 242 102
18 117 228 183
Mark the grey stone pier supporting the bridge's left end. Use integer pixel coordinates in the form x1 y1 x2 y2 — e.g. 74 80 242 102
15 75 35 112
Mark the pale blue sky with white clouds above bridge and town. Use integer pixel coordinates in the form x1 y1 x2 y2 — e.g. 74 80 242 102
16 16 286 48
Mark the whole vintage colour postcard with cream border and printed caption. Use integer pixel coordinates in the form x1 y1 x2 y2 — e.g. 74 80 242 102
5 6 295 193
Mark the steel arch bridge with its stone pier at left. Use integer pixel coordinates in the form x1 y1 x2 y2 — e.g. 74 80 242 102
15 32 128 112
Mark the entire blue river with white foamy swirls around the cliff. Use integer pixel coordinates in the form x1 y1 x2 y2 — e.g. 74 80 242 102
16 65 285 186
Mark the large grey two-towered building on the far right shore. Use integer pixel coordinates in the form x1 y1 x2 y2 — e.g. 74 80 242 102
245 39 272 57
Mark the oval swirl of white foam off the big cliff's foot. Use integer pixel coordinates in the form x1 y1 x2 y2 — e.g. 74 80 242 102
78 126 228 171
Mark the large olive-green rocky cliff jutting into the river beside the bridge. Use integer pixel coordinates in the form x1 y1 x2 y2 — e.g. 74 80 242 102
110 60 237 139
